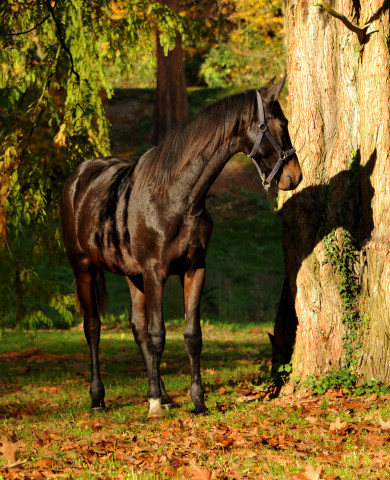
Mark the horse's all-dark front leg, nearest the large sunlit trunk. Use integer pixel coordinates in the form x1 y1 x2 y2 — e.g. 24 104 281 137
182 268 207 413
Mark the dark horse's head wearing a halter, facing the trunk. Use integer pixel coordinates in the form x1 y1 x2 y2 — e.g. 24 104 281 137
245 77 302 190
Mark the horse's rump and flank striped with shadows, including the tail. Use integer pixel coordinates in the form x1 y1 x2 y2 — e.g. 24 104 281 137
61 157 137 313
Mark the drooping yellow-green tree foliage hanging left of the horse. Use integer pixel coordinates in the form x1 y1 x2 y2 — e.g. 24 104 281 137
0 0 188 326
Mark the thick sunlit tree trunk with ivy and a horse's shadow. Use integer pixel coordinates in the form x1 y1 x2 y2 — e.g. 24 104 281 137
273 0 390 383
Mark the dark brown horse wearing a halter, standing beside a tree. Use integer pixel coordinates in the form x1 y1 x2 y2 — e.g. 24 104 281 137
61 77 302 418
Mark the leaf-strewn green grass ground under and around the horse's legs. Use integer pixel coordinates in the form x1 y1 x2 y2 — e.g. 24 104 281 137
0 328 390 480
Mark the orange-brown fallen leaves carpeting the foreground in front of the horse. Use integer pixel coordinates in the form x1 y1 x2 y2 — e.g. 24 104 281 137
0 392 390 480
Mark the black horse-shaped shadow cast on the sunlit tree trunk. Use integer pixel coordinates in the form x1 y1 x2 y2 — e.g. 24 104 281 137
270 150 377 364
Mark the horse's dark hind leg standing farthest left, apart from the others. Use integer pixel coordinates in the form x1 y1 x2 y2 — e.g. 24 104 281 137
75 264 105 408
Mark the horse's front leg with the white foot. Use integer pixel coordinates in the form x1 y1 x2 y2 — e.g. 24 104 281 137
144 273 165 418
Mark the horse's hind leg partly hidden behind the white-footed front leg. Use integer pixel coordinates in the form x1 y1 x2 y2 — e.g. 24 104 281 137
126 277 173 416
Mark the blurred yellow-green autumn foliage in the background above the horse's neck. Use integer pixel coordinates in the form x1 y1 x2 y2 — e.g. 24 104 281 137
122 0 286 88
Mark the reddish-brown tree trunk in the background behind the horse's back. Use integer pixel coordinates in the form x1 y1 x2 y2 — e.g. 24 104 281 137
150 0 188 145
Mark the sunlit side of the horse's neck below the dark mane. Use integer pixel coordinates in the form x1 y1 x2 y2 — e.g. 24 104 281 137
172 137 242 215
